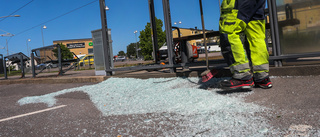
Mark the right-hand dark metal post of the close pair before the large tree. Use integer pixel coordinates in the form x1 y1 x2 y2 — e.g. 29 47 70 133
162 0 176 73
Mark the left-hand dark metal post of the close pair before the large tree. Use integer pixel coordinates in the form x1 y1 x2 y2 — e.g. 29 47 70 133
148 0 160 63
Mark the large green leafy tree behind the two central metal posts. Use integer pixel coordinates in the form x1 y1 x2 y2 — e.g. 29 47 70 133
139 18 166 60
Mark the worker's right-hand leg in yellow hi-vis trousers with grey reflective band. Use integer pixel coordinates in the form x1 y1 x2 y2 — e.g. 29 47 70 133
245 0 272 88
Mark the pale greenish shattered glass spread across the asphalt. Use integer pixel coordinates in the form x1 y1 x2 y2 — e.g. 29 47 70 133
18 77 280 136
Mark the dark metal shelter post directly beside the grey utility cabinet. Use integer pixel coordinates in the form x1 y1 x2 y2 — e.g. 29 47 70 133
99 0 112 76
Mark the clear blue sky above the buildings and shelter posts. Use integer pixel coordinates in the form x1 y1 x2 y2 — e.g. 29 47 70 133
0 0 219 56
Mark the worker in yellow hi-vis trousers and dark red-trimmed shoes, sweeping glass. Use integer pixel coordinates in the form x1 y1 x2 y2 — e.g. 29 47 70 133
219 0 272 89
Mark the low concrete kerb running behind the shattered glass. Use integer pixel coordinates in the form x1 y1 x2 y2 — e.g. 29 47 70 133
0 65 320 85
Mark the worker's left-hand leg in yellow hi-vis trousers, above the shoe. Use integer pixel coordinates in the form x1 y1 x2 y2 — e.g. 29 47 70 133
219 0 252 80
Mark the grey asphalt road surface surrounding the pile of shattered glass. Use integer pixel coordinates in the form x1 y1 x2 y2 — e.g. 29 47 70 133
0 76 320 137
